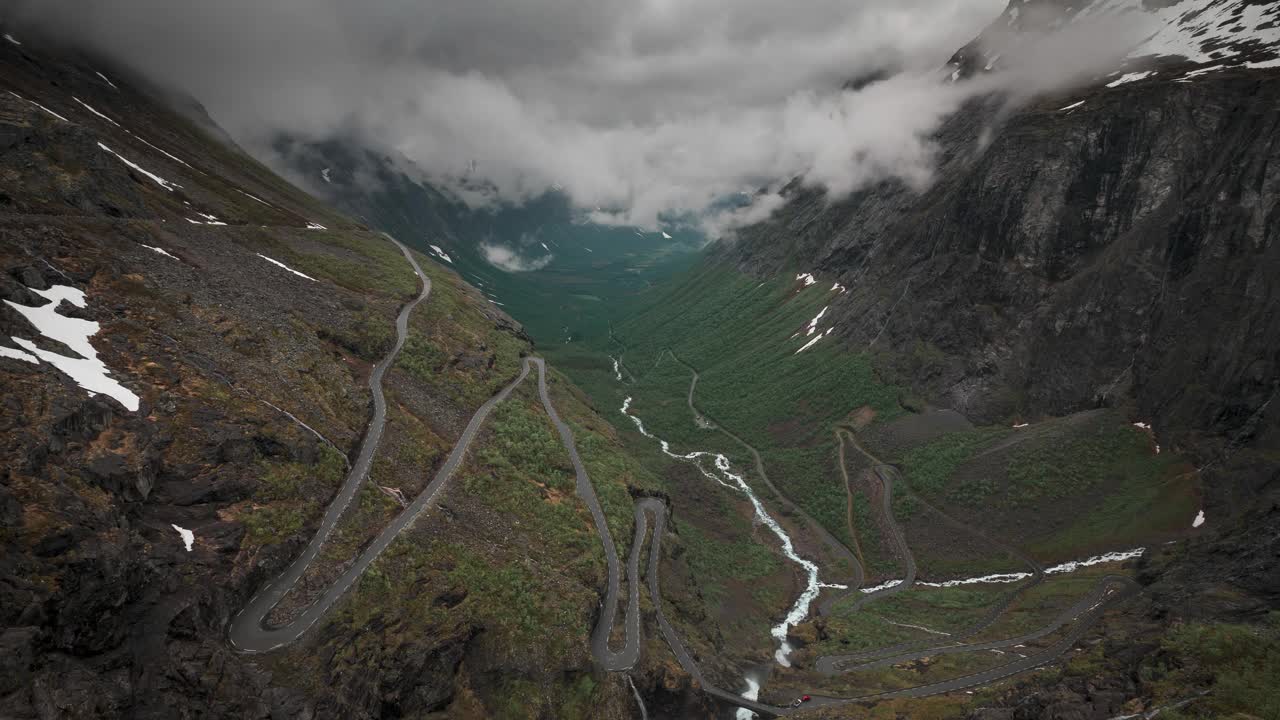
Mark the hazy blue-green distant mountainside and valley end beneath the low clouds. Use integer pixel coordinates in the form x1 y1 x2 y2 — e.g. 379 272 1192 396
274 137 703 346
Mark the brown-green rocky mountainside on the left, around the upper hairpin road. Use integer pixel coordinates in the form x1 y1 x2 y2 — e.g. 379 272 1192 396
0 28 713 717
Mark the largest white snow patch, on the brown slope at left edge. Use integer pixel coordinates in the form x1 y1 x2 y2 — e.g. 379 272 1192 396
5 284 140 411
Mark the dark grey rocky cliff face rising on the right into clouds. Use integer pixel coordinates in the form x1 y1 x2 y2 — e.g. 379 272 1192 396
716 1 1280 717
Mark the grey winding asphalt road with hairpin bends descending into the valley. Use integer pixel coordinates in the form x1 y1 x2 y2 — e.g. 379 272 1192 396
228 243 1137 716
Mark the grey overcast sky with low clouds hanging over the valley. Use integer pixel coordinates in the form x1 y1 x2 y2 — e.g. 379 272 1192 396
3 0 1141 224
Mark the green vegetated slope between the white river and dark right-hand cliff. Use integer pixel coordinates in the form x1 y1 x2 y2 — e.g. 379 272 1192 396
596 260 902 543
